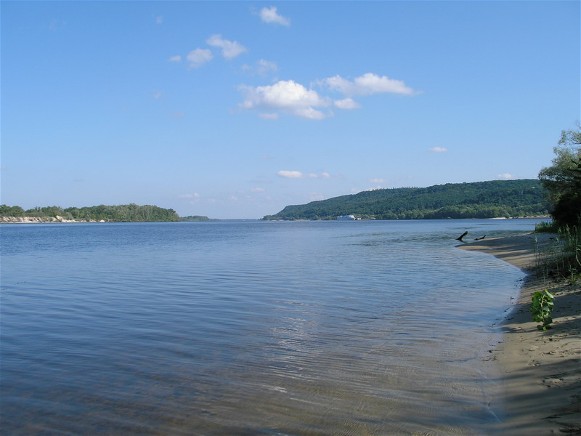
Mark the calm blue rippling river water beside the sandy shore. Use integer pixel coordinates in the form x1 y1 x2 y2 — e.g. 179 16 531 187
0 220 535 435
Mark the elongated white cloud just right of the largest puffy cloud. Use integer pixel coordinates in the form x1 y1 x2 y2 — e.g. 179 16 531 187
322 73 415 96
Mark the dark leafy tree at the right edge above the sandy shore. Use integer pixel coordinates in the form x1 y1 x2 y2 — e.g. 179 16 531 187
539 125 581 226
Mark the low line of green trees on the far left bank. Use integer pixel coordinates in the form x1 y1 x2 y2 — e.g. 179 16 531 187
0 203 179 222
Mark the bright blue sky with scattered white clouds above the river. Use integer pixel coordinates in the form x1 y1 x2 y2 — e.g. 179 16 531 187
0 1 581 218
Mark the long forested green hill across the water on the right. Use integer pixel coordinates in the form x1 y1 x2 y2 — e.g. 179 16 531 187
263 179 549 220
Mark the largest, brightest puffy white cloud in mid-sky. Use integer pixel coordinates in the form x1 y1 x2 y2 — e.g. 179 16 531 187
241 80 329 120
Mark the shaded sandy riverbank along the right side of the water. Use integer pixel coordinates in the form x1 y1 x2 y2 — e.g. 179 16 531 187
459 234 581 435
